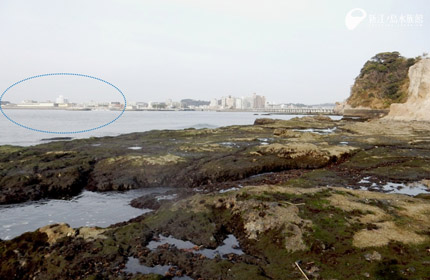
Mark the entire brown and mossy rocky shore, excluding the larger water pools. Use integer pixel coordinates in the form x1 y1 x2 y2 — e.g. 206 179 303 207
0 116 430 279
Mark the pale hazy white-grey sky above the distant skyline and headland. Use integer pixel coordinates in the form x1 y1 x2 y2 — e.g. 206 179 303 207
0 0 430 104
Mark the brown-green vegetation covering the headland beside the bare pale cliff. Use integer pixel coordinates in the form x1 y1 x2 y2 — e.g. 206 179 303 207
347 52 417 109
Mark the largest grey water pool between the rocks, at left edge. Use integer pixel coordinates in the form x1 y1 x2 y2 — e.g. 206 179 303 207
0 188 171 240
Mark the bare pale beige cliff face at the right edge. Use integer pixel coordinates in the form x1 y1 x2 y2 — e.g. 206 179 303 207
385 58 430 121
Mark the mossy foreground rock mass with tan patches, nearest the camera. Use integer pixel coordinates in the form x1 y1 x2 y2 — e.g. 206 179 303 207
0 184 430 279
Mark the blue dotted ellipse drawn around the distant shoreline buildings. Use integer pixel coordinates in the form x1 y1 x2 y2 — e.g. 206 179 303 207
0 73 127 134
